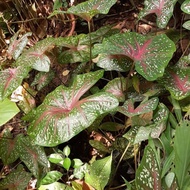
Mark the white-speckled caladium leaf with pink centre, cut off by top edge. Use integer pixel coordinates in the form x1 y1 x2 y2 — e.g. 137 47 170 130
139 0 177 28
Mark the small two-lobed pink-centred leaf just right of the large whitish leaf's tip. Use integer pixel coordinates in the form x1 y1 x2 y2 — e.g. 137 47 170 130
118 97 159 117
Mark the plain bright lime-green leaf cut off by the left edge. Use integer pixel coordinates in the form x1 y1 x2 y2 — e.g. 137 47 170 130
0 98 20 126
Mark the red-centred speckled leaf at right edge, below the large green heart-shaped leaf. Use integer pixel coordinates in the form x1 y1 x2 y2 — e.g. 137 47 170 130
159 56 190 100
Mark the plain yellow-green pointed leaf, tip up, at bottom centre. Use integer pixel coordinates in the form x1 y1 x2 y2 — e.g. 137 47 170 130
85 155 112 190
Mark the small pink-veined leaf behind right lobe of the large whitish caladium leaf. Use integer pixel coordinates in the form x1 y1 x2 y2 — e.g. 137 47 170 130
104 77 127 102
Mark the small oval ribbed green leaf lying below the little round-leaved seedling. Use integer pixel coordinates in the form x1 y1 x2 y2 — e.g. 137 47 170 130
40 171 63 185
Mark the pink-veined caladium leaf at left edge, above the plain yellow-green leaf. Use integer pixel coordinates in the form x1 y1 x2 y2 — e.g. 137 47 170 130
0 66 30 101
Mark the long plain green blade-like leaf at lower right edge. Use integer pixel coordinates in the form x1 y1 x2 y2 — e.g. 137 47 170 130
174 121 190 189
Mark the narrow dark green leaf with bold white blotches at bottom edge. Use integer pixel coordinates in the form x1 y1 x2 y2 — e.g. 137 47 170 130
135 146 161 190
